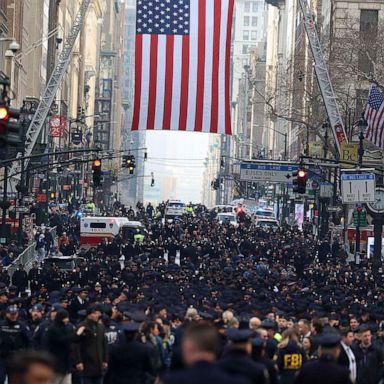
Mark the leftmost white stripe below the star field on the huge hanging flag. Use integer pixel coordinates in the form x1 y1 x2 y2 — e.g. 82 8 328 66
139 35 151 130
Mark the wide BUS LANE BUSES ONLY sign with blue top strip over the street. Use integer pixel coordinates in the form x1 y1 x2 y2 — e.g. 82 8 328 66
240 163 298 184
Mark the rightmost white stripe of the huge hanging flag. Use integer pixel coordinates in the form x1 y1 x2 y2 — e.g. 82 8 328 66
217 0 229 133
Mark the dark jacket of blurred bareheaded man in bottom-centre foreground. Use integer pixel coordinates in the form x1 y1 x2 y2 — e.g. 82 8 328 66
161 361 249 384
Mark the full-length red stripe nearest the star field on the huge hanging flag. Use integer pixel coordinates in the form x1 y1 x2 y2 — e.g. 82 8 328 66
195 0 206 132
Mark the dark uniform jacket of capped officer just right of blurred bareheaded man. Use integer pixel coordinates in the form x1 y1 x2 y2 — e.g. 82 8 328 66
217 349 269 384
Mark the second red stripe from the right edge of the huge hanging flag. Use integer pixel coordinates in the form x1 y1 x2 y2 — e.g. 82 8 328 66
210 0 221 133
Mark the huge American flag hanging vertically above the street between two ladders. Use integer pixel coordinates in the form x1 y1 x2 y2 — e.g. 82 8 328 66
132 0 234 134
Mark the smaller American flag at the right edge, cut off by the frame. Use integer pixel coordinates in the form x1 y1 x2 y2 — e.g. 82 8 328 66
364 85 384 148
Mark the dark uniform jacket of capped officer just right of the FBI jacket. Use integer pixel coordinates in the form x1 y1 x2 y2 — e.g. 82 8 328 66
295 355 352 384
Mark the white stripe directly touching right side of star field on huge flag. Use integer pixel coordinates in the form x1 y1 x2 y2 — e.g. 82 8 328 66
185 0 199 131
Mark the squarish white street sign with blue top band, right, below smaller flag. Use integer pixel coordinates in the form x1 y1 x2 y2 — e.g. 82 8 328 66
341 173 376 204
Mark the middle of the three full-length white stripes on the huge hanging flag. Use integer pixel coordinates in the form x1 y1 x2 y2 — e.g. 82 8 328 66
202 0 215 132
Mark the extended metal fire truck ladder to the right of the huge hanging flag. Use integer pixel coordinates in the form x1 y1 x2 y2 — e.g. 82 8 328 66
299 0 348 153
